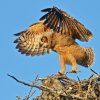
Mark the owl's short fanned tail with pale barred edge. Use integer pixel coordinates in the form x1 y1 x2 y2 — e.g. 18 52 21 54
80 48 95 68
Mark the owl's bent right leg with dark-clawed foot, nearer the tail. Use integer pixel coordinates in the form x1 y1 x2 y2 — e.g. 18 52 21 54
67 54 80 73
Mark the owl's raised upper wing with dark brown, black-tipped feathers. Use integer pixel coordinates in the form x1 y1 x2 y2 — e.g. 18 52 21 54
40 7 92 41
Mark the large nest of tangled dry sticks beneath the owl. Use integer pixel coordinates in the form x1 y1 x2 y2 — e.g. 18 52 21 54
8 70 100 100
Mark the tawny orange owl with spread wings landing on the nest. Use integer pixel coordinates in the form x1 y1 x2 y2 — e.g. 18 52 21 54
14 7 94 74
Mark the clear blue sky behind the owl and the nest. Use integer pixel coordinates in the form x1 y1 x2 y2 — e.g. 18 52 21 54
0 0 100 100
